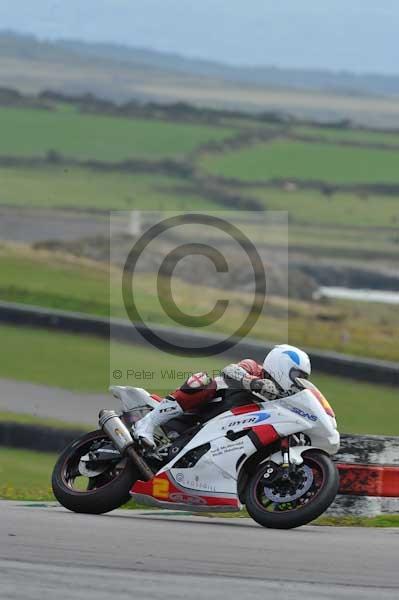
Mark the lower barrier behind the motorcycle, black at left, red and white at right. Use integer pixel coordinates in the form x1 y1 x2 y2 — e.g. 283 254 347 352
0 423 399 516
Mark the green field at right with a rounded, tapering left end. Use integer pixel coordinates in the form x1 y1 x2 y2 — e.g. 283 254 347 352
201 139 399 183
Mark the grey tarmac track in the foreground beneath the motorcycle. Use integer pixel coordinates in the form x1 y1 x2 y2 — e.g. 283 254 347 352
0 502 399 600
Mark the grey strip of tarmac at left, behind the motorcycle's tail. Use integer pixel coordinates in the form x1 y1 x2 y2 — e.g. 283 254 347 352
0 379 109 429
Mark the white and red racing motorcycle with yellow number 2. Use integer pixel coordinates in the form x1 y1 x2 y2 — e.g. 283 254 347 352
52 379 340 529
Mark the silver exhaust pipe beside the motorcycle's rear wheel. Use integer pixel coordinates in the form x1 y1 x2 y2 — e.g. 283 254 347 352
98 409 154 481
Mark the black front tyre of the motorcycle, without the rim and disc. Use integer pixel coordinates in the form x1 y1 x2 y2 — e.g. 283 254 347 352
245 450 339 529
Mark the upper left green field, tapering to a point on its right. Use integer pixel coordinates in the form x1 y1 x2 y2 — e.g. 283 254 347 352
0 107 234 162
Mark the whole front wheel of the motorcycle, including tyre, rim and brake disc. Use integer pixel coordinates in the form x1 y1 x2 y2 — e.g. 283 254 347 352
245 450 339 529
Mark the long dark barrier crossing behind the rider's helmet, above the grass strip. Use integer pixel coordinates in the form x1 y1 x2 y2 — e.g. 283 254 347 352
0 302 399 386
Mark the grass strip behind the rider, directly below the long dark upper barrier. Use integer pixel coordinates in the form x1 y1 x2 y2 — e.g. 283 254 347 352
0 326 399 435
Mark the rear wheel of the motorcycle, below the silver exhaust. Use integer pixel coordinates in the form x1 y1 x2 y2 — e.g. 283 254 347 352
52 430 138 514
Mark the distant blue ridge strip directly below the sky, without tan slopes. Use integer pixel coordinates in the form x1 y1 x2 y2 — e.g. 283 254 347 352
0 32 399 96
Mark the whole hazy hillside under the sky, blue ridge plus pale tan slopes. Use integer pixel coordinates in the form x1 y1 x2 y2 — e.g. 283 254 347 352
0 32 399 127
